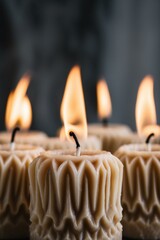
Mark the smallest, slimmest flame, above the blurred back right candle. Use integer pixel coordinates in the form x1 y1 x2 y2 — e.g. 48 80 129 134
97 80 112 119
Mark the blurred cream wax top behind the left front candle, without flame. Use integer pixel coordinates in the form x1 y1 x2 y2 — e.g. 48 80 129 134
0 131 48 146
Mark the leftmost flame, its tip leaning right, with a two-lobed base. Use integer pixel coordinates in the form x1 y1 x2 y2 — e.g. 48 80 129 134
5 74 32 129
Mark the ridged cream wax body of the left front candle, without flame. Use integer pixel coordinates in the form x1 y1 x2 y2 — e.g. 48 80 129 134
0 144 43 239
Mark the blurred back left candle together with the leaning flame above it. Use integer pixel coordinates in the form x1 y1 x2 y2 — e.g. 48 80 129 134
0 74 47 144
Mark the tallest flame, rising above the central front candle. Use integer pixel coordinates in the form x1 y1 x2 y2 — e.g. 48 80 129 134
61 66 87 139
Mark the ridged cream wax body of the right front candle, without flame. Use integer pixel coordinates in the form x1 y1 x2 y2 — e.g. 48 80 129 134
115 144 160 240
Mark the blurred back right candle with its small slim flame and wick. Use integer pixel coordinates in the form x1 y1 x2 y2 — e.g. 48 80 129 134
88 80 141 153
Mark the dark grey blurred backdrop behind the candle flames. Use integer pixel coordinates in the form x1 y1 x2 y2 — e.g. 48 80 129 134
0 0 160 135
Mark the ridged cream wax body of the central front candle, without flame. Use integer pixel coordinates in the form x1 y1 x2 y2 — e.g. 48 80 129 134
29 150 123 240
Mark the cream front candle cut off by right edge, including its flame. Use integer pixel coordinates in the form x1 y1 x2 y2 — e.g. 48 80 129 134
115 76 160 240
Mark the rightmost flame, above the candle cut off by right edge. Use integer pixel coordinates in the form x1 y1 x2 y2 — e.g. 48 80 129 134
135 76 158 135
